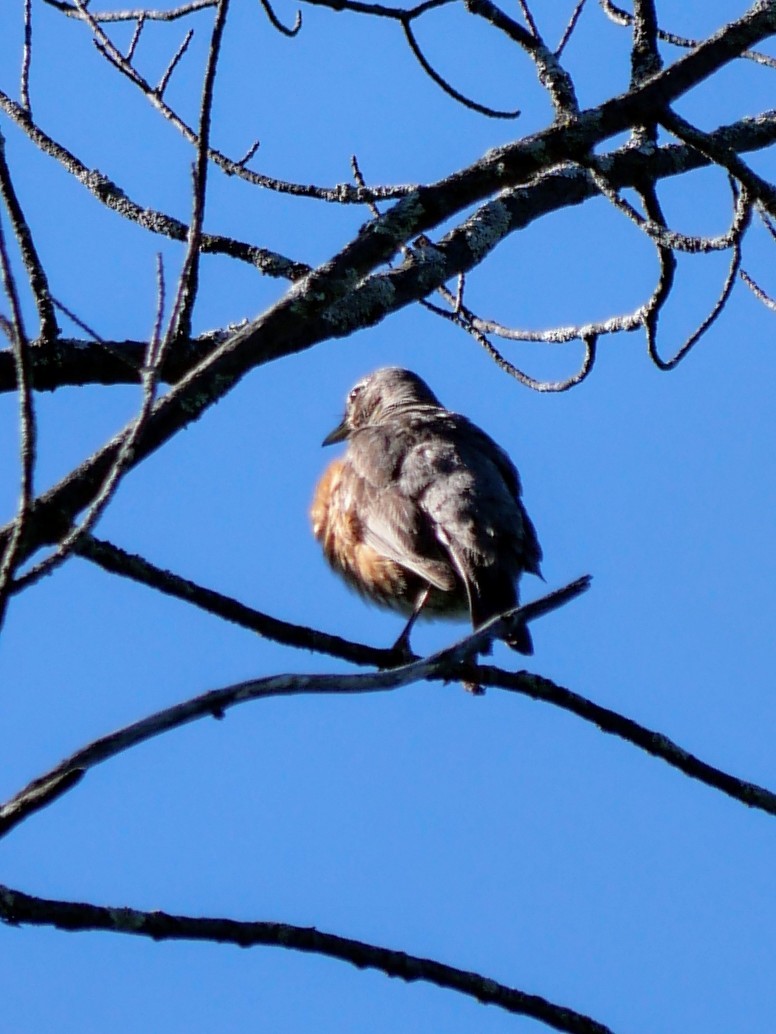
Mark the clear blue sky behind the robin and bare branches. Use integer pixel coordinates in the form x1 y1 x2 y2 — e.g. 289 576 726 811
0 0 776 1034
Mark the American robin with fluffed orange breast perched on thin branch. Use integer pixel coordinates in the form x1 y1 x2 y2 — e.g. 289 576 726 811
310 366 541 653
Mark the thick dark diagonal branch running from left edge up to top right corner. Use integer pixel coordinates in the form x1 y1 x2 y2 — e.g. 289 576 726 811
0 3 776 555
